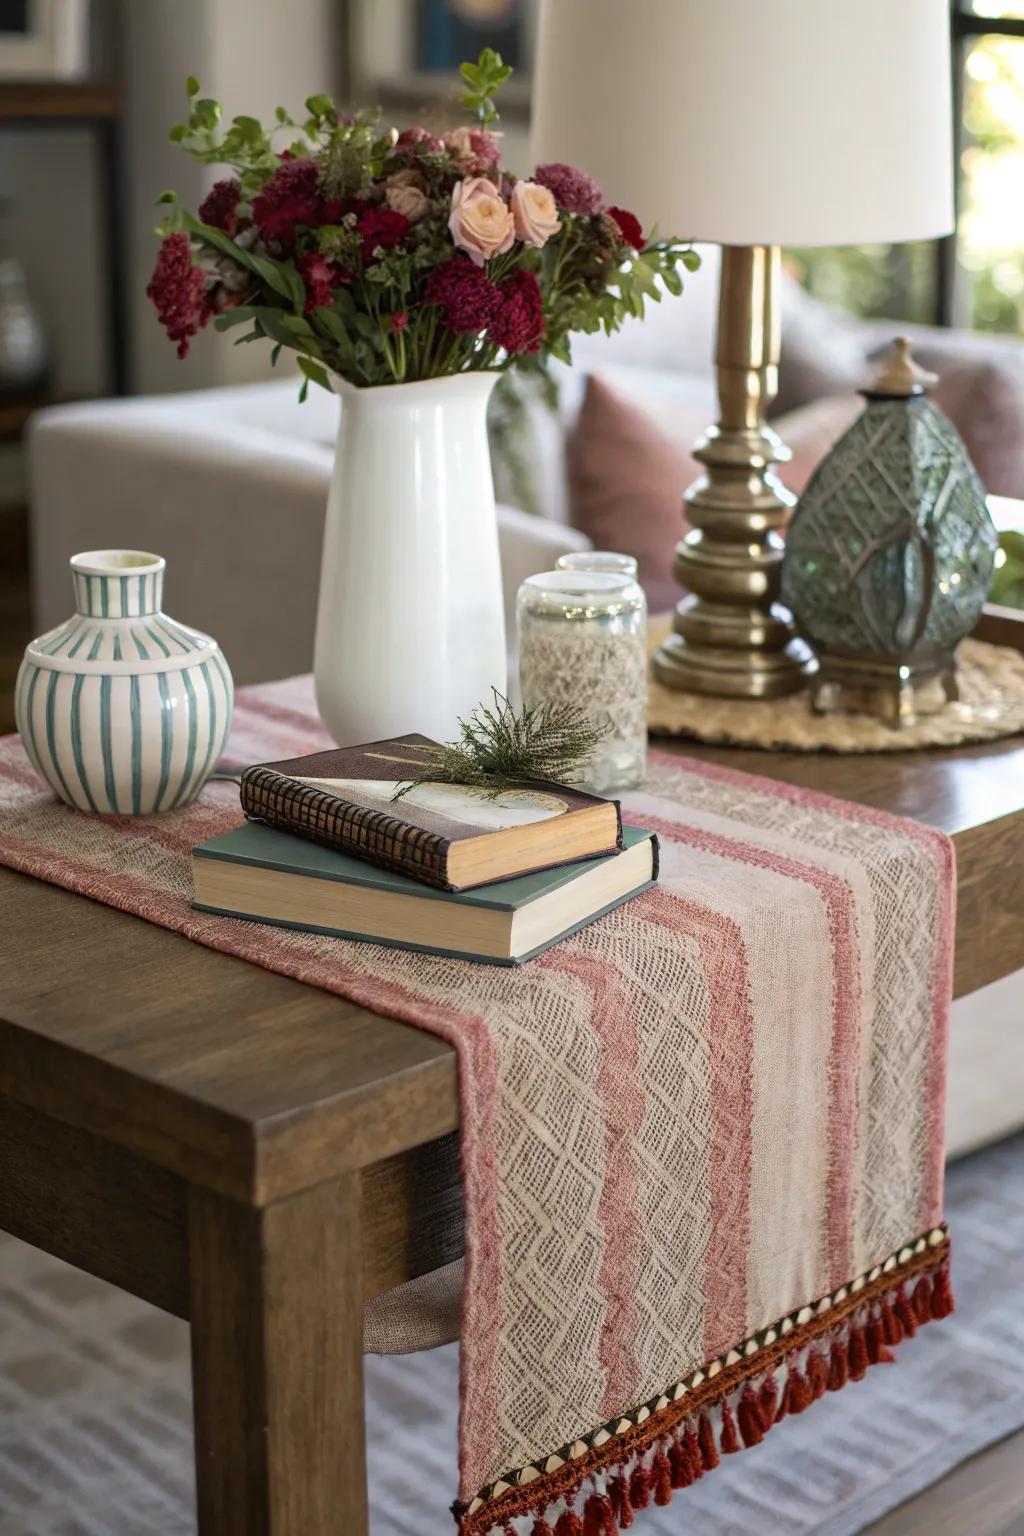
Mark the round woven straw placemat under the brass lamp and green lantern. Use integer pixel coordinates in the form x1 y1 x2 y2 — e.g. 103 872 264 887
648 614 1024 753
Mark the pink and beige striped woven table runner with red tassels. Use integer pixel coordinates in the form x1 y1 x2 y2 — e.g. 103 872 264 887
0 679 953 1536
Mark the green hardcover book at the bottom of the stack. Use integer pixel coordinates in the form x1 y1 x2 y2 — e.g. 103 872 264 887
192 822 659 965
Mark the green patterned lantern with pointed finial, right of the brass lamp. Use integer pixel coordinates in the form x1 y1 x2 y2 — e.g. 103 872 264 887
781 338 996 725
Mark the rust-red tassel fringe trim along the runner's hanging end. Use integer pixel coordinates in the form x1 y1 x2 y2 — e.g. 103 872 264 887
453 1227 953 1536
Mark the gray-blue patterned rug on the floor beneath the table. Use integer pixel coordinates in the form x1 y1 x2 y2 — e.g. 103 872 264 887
0 1137 1024 1536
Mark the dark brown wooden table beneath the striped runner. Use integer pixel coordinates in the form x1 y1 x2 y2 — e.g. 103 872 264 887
0 605 1024 1536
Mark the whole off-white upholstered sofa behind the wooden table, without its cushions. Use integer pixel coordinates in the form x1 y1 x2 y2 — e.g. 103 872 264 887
23 276 1024 1155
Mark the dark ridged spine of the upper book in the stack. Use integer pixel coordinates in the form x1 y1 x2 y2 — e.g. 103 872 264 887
241 768 451 891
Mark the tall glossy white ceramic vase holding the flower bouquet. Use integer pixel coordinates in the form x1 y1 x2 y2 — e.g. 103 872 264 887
315 373 507 745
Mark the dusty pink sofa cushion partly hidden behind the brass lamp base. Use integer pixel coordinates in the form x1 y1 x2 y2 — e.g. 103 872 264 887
568 370 863 611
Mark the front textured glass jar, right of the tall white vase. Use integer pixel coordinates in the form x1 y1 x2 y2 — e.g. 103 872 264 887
516 570 646 794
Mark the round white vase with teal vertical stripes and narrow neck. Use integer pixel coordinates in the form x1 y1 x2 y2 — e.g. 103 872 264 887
14 550 235 816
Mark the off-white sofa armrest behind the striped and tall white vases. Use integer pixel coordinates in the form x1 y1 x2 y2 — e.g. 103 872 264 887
31 379 601 684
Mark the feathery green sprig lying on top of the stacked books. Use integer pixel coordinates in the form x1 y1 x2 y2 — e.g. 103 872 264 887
393 688 608 800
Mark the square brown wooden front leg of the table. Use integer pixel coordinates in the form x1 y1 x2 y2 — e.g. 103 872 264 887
189 1177 368 1536
